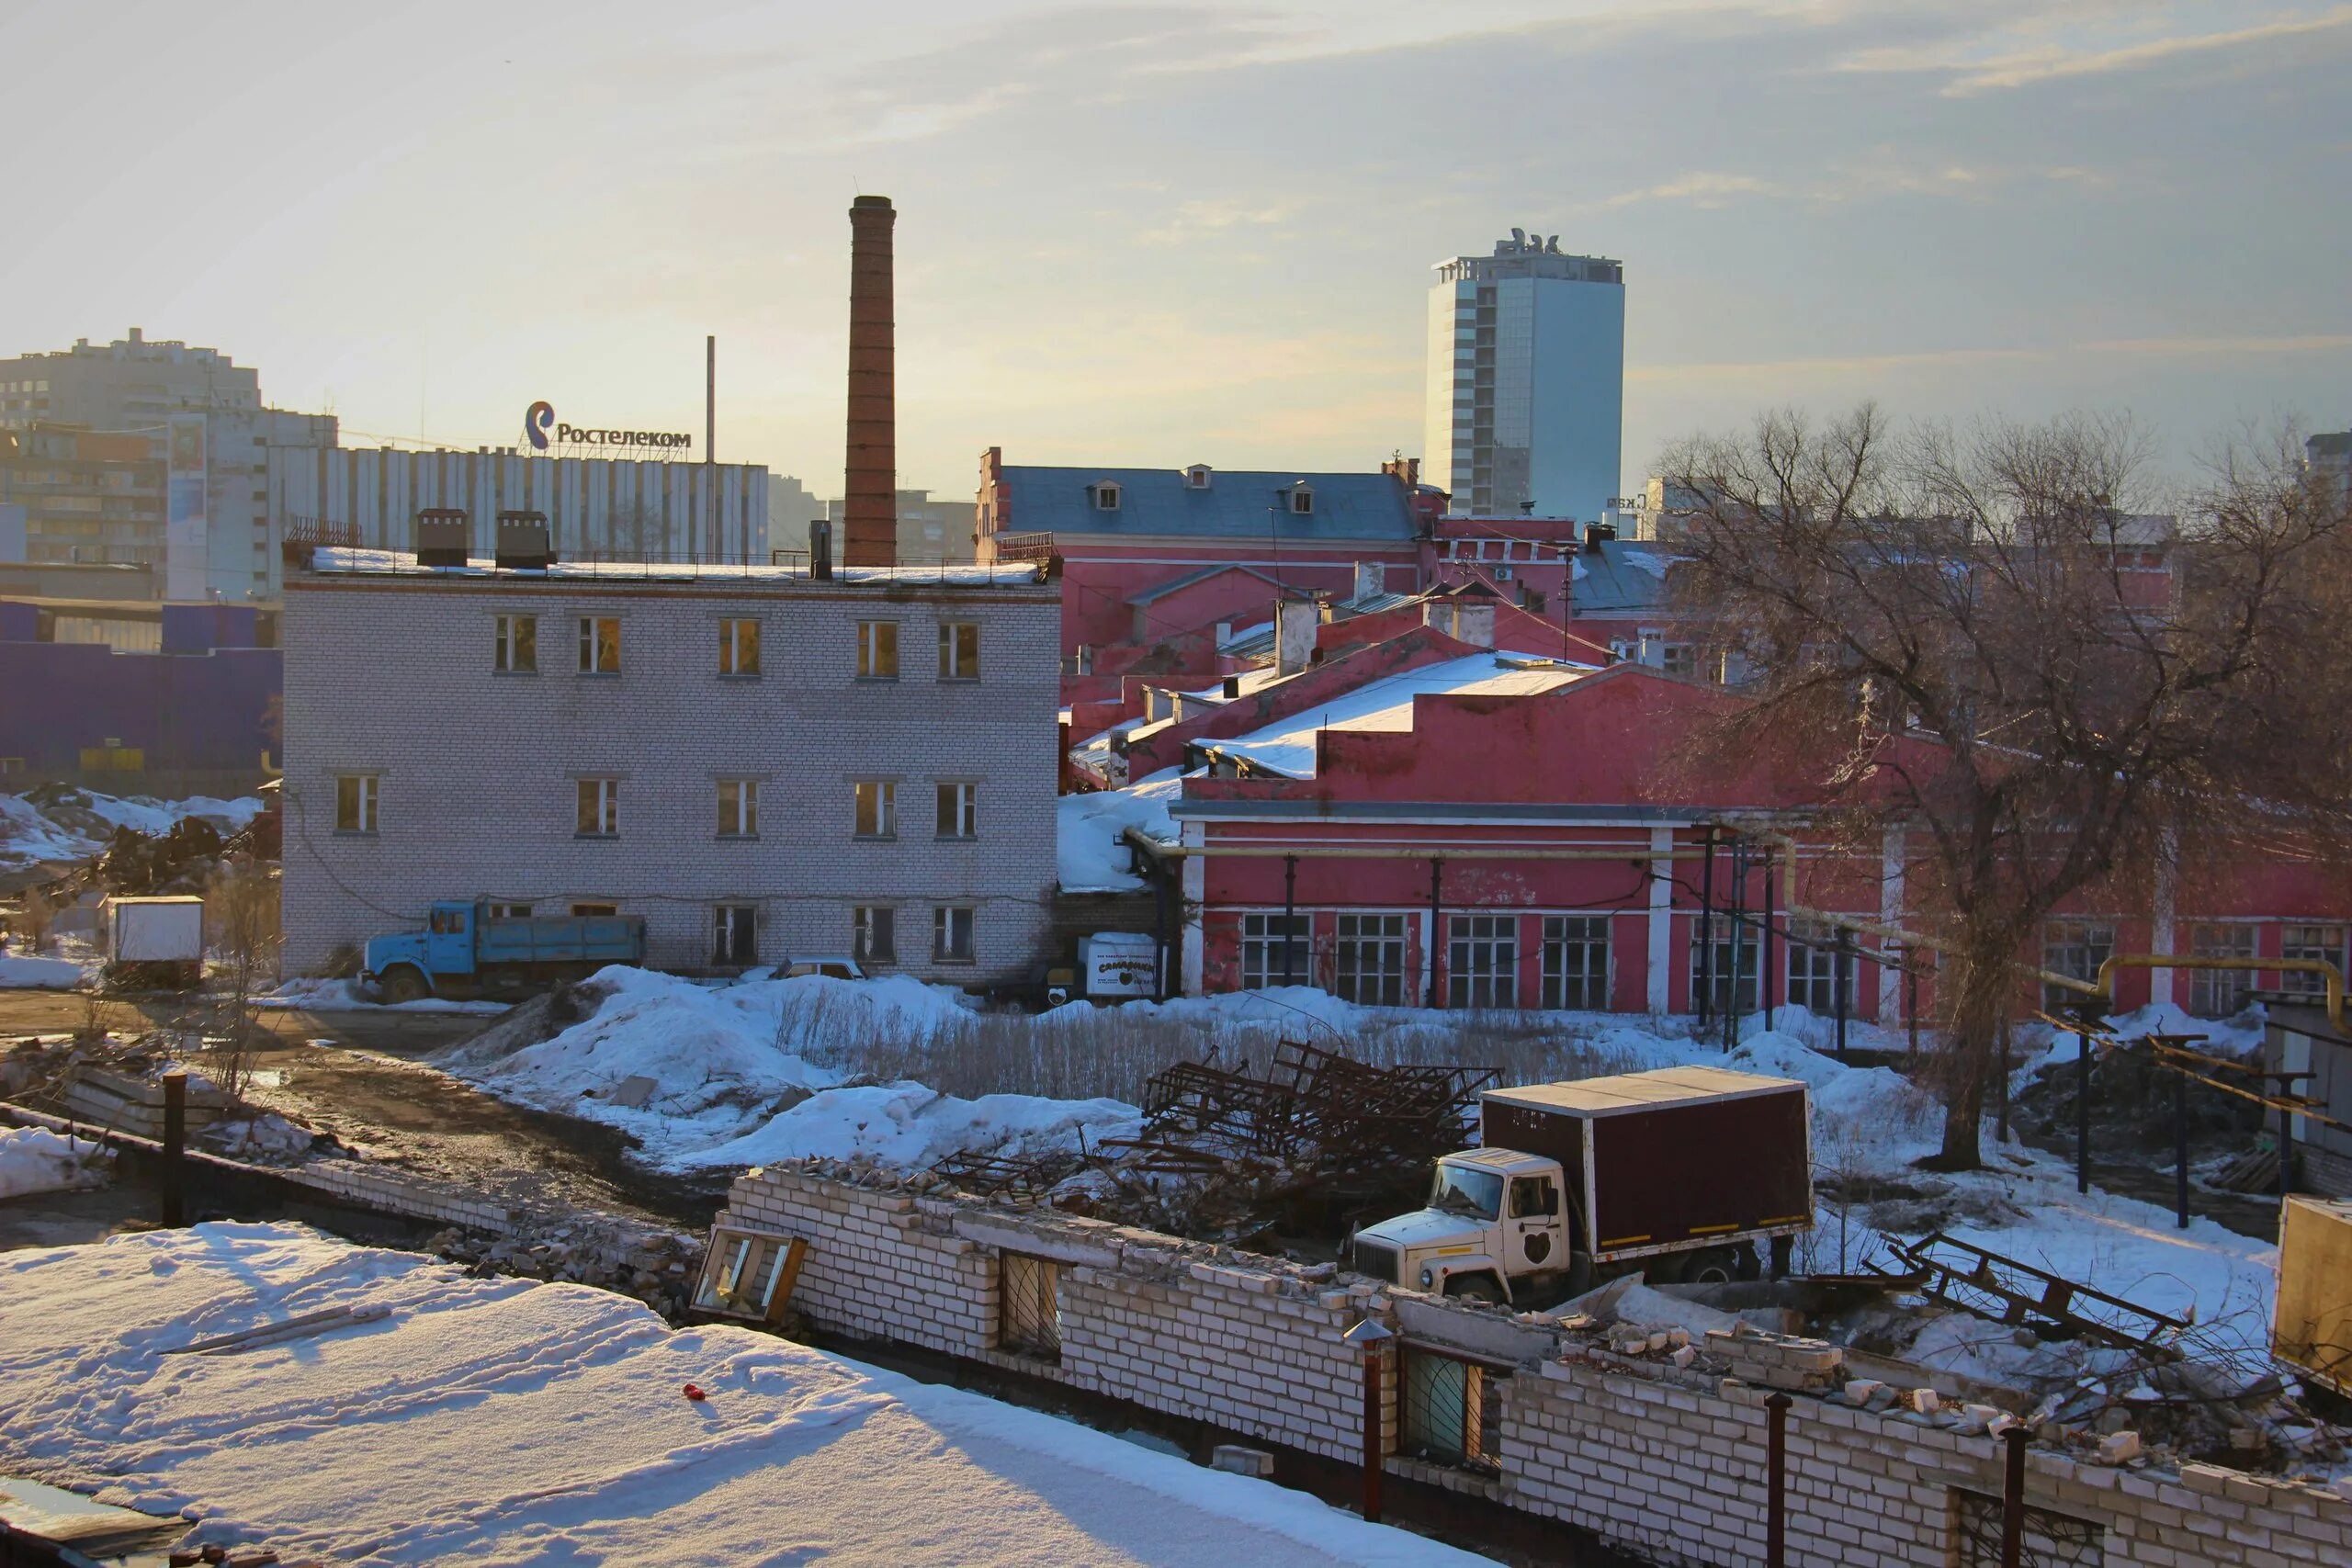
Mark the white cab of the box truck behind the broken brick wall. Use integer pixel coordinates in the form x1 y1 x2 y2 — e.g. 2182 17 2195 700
1355 1149 1574 1303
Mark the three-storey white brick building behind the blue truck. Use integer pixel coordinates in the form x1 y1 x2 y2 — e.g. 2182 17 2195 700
285 550 1061 983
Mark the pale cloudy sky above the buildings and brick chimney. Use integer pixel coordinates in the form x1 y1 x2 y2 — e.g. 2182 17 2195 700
0 0 2352 496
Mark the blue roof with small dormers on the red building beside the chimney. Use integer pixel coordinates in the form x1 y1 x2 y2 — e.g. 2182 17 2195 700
1002 466 1419 541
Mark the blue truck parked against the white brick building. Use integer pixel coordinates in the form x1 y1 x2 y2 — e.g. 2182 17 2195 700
362 903 644 1001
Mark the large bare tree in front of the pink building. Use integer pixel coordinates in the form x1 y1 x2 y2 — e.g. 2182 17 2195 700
1663 404 2352 1168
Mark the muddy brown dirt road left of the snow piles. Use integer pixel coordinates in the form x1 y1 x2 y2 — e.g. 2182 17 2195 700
0 989 724 1229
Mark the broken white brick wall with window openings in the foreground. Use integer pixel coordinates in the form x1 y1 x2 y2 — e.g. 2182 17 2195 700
713 1161 2352 1568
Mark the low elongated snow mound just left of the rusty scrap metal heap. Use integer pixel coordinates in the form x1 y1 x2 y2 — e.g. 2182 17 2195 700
677 1084 1143 1170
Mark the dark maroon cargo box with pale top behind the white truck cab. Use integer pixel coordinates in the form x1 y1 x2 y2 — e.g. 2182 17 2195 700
1479 1067 1814 1260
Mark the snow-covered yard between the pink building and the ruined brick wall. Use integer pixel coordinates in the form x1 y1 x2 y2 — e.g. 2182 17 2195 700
423 968 2277 1380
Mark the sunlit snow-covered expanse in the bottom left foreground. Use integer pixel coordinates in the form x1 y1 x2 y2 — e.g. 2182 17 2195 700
0 1224 1484 1568
